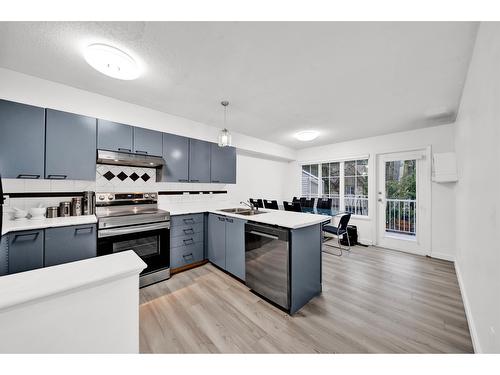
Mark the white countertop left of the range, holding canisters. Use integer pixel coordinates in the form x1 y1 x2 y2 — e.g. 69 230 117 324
2 215 97 236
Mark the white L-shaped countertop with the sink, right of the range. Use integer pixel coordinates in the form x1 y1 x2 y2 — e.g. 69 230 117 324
160 202 331 229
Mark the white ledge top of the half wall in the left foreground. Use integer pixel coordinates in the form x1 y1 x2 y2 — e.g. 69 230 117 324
0 250 146 312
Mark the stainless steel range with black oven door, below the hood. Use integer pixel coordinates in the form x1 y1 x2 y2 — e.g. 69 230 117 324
96 193 170 287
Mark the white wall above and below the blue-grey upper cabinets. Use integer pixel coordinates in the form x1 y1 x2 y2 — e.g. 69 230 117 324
0 68 296 209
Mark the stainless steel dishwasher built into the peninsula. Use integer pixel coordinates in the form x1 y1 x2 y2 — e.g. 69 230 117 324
245 223 290 310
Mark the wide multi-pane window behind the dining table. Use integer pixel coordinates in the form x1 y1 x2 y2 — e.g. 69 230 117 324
302 159 368 216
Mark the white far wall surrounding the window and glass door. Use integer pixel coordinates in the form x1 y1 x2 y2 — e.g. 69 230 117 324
285 125 455 260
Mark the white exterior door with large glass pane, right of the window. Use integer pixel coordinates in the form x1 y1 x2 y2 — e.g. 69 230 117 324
377 150 431 255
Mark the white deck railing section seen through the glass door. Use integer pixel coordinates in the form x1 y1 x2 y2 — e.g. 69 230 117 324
385 199 417 235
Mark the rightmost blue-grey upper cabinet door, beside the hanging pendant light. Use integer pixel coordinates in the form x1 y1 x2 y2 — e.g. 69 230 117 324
210 143 236 184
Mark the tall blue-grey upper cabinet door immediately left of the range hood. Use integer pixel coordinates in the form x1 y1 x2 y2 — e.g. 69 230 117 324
45 109 96 180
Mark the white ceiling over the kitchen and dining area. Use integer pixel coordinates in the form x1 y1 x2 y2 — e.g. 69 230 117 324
0 22 477 148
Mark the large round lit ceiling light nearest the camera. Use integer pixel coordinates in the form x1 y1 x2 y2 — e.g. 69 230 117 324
85 43 141 80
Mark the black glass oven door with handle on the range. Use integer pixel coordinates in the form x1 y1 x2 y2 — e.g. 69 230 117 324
97 221 170 281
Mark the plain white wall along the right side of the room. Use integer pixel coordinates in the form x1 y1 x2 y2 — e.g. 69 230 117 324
455 22 500 353
